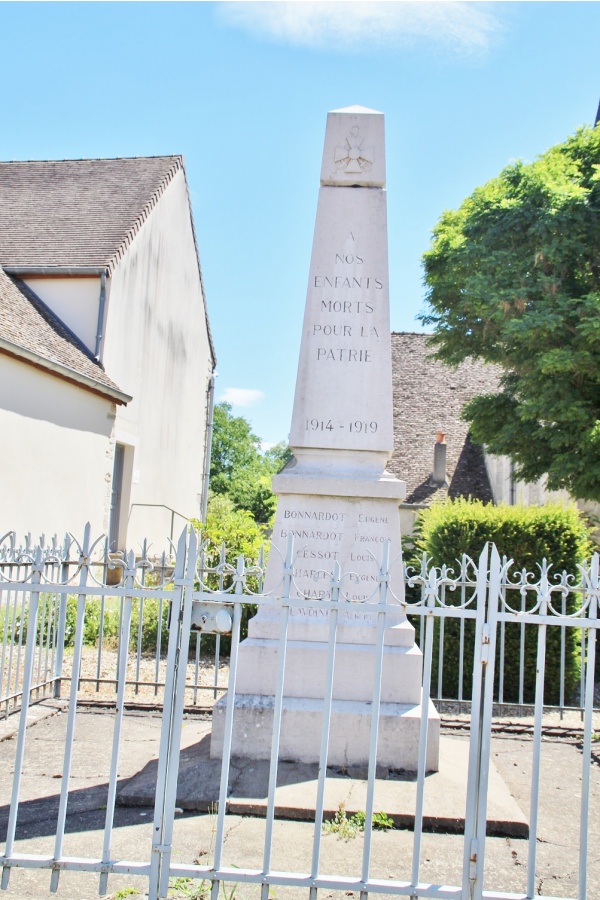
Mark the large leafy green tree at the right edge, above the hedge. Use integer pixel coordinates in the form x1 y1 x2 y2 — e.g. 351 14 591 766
420 127 600 500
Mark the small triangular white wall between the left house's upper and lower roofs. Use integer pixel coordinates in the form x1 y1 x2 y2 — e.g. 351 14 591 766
23 275 100 353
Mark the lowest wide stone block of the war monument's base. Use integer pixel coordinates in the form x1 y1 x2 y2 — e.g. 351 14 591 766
210 694 440 772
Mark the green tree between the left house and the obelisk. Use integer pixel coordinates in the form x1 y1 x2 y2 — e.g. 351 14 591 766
210 403 291 524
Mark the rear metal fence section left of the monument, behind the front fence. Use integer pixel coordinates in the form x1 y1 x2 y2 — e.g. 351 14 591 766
0 532 246 717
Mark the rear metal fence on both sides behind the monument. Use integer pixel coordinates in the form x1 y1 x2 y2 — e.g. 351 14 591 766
0 533 600 716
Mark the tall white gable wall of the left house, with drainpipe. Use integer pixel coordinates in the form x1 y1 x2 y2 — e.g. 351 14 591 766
103 172 212 549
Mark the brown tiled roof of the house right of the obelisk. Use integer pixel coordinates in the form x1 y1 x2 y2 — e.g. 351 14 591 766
388 332 499 503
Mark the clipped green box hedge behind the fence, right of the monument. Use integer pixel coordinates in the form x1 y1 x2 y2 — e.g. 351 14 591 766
412 499 591 705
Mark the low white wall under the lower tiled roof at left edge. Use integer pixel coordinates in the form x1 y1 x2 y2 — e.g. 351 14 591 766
0 354 115 539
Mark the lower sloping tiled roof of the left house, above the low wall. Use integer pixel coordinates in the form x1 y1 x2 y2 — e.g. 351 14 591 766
0 268 131 402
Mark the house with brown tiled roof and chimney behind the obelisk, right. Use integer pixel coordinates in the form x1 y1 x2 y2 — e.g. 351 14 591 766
388 332 570 534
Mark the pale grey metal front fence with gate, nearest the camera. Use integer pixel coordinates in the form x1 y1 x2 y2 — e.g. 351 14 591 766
0 531 599 900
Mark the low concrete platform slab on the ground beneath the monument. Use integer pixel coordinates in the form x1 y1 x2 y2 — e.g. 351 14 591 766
117 734 529 838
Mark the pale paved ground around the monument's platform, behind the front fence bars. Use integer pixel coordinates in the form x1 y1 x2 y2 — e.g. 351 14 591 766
0 709 600 900
